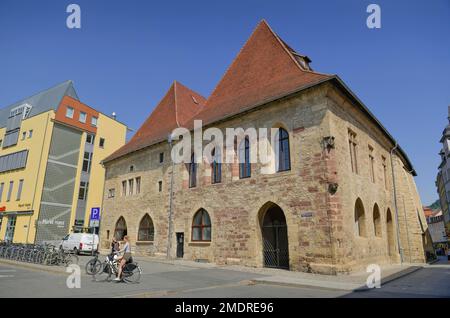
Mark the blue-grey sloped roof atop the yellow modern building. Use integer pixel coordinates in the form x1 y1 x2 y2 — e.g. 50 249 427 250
0 80 78 128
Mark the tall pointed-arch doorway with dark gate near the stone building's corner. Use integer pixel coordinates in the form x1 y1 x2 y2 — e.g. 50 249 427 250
261 204 289 269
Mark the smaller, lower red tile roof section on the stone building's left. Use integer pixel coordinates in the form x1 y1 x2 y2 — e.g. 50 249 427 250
104 81 206 162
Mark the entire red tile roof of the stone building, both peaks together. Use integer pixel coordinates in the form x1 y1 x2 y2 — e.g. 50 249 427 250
104 20 332 161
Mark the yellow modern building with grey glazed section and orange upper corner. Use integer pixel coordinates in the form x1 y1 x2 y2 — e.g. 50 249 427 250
0 81 127 243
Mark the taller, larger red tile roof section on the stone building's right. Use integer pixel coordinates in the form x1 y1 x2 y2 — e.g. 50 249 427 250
196 20 331 124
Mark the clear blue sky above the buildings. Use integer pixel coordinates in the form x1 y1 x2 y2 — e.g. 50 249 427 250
0 0 450 204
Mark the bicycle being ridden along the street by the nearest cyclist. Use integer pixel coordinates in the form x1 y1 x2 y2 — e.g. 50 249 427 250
93 254 142 283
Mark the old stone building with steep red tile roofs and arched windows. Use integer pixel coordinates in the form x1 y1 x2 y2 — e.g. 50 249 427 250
101 21 427 274
